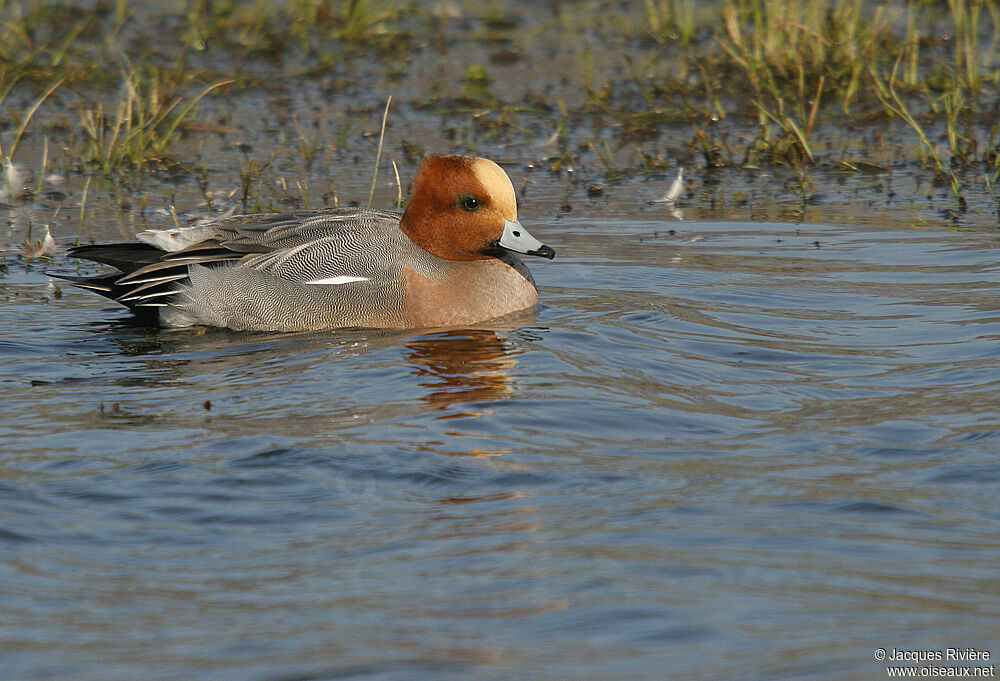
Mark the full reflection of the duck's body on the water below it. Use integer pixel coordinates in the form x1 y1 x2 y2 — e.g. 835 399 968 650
68 326 532 436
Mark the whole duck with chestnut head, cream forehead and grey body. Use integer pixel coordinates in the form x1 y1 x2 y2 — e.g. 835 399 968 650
61 155 555 331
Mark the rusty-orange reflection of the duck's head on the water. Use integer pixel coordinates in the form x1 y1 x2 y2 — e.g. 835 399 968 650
406 329 517 416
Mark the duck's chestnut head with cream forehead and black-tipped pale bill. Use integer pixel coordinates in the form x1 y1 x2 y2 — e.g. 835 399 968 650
400 156 556 260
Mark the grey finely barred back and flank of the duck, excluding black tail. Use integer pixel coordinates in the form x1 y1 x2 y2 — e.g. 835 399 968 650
160 209 433 330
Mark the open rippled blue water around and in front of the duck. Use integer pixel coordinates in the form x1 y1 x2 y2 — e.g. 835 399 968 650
0 216 1000 680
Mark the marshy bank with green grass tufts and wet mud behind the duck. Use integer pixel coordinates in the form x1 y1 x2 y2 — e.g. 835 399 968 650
0 0 1000 231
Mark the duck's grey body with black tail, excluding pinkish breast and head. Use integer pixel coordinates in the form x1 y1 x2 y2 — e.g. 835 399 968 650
64 209 450 329
